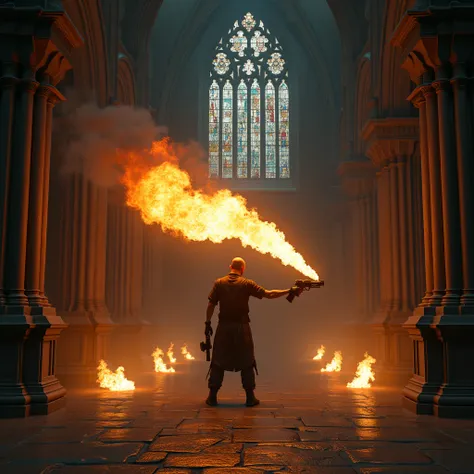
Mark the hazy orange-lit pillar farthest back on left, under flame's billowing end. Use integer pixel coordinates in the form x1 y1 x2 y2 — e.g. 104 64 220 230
106 189 144 365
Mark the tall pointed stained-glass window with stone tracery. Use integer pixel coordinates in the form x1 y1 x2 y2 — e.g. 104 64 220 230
209 13 290 180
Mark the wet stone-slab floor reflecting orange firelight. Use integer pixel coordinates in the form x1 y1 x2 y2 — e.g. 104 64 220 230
0 362 474 474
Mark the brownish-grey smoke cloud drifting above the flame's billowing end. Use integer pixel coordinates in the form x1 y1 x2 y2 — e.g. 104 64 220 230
54 104 207 187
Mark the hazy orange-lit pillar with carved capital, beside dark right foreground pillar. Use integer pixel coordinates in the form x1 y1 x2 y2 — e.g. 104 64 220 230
363 118 422 382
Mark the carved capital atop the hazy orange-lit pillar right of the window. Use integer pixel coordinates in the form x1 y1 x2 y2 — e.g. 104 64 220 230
362 117 419 167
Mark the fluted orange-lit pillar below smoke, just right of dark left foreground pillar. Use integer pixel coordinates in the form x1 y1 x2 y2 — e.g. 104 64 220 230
57 178 113 386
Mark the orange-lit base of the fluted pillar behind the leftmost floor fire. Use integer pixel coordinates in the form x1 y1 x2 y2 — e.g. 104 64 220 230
57 311 113 388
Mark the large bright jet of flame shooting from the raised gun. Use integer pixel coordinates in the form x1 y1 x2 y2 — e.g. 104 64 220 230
121 139 319 280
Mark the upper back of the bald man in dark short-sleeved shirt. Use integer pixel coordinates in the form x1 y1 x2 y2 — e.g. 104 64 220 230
209 273 265 322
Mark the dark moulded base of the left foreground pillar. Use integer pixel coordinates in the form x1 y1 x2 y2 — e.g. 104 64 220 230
0 306 66 418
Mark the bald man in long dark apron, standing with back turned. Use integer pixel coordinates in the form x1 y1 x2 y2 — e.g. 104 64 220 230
204 257 301 407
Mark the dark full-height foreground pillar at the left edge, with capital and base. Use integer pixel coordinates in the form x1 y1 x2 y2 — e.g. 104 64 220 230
0 3 81 417
